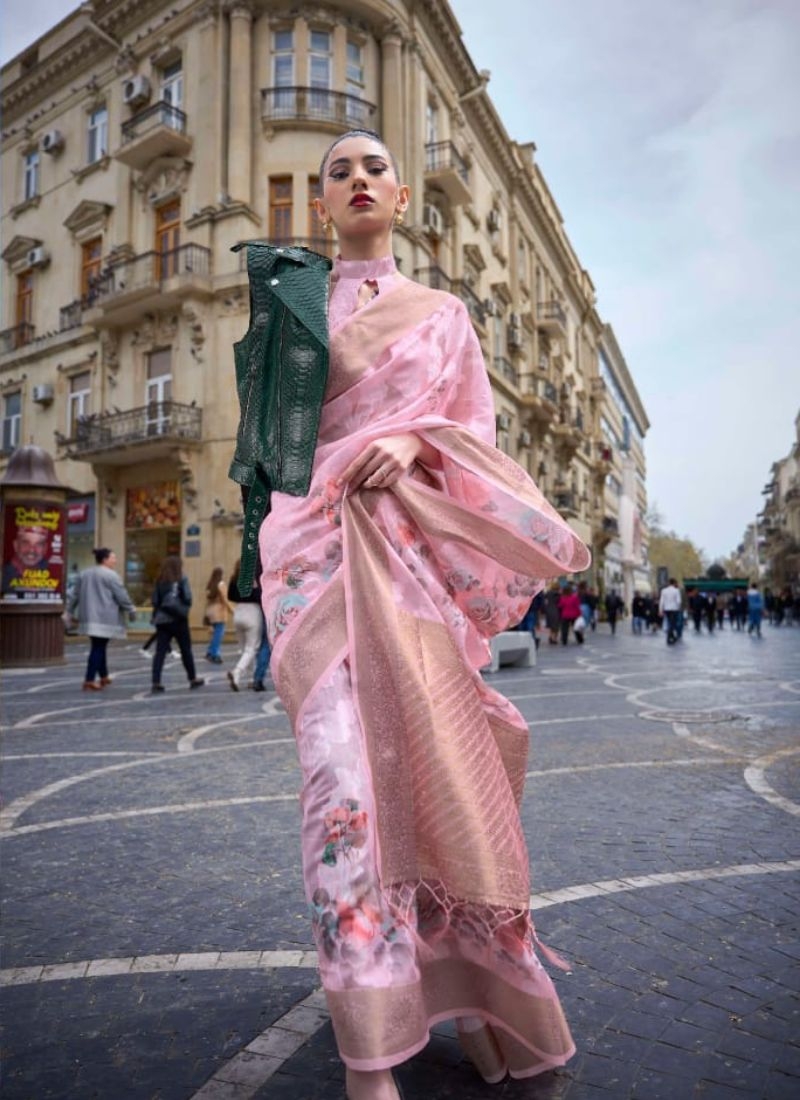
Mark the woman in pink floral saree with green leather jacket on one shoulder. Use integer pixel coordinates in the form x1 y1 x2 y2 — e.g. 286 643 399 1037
231 131 590 1100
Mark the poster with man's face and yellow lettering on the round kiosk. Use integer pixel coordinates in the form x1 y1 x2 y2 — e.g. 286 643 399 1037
1 501 66 602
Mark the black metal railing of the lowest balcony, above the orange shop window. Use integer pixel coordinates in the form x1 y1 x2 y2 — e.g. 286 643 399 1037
67 402 202 455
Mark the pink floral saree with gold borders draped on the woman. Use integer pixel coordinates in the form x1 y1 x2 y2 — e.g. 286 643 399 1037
260 279 589 1077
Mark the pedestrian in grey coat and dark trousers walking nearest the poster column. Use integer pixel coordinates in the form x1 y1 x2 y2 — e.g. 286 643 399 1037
68 547 136 691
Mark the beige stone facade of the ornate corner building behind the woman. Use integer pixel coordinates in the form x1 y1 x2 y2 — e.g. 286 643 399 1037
0 0 647 603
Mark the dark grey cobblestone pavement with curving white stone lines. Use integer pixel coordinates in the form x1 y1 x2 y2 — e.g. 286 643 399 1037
0 624 800 1100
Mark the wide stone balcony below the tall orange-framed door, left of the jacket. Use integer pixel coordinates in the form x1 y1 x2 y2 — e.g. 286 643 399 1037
83 244 211 328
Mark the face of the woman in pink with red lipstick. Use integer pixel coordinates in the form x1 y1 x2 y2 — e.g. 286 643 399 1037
316 136 408 238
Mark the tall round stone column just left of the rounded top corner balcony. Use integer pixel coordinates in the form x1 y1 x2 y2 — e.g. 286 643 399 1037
228 0 253 206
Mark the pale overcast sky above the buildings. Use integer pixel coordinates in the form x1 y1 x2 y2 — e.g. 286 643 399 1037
0 0 800 558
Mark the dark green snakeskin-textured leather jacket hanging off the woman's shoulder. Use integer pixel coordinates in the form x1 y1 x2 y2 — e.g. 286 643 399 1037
229 242 332 595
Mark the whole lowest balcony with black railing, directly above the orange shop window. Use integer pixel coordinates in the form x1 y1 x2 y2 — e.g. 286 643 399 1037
64 402 202 466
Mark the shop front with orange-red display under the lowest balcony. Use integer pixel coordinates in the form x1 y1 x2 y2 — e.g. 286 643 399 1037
124 481 180 608
